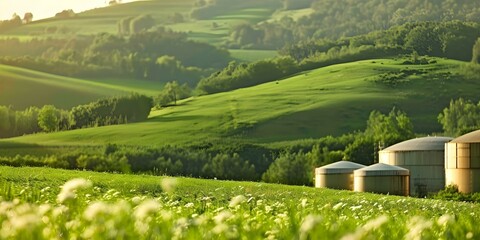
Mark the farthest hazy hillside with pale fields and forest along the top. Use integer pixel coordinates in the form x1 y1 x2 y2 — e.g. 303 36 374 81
4 0 480 49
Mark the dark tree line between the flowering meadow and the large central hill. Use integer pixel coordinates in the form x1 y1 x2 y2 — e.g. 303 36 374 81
0 109 414 185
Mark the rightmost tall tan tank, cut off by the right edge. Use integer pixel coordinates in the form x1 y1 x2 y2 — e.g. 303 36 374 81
445 130 480 193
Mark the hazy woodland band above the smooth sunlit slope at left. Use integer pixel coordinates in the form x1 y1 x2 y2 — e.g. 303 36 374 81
0 27 230 87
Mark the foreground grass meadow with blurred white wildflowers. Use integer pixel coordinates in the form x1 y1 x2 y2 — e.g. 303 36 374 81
0 167 480 239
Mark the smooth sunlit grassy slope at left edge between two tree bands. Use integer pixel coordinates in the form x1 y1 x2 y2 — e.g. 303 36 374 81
0 65 162 109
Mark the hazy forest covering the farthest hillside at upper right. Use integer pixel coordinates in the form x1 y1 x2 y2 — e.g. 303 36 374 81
225 0 480 49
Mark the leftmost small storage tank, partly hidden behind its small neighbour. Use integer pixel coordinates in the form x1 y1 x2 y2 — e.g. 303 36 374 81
315 161 365 190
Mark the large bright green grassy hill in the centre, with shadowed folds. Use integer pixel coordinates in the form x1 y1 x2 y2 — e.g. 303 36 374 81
4 59 479 145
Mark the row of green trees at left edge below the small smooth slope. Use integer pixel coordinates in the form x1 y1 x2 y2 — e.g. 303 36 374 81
0 94 153 138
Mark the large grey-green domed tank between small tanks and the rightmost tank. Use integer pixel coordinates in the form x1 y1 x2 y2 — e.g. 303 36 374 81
378 137 453 197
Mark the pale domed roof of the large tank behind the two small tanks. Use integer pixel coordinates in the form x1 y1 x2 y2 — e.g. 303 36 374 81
380 137 453 152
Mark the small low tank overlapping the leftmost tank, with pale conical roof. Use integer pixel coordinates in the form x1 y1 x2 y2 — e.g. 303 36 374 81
353 163 410 196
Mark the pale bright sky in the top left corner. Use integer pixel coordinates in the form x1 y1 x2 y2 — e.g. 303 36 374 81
0 0 132 21
